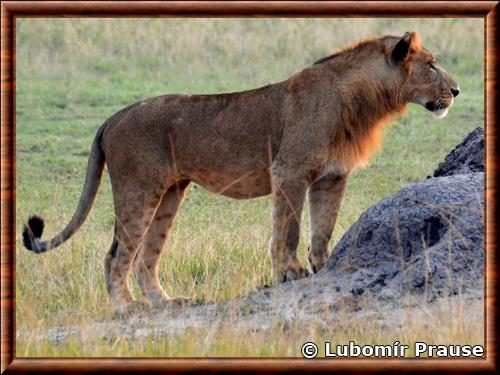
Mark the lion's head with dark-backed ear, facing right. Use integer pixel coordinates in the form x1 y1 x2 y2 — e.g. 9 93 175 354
390 32 460 118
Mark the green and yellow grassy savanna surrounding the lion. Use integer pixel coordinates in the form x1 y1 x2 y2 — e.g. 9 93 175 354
16 19 483 356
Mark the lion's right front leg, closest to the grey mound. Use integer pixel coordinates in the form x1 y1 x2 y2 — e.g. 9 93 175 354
308 174 348 273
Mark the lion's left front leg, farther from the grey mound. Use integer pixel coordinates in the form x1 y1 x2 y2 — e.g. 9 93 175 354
270 178 308 283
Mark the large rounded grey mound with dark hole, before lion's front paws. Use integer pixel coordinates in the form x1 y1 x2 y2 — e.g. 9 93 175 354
318 173 484 299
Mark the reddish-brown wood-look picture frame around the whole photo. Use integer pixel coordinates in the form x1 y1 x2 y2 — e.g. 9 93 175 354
1 1 500 373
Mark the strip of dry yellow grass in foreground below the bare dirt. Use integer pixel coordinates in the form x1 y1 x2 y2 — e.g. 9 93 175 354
19 297 484 358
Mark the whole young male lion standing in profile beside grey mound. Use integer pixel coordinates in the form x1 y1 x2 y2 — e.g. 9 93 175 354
23 32 459 313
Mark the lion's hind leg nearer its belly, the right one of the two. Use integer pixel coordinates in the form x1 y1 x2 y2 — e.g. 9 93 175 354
134 180 190 307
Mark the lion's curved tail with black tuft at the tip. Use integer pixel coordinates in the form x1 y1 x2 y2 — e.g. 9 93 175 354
23 126 105 254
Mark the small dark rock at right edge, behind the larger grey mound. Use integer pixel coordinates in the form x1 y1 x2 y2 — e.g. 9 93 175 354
434 128 484 177
